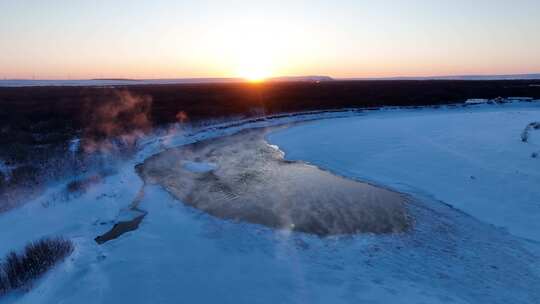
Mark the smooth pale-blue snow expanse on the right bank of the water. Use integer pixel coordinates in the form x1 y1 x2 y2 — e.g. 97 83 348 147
269 104 540 241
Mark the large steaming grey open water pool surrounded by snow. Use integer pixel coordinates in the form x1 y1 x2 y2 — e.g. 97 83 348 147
137 129 411 236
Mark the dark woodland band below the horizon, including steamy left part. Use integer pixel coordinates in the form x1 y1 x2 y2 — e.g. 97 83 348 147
0 80 540 161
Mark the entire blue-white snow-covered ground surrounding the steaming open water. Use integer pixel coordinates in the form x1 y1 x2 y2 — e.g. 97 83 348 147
0 103 540 303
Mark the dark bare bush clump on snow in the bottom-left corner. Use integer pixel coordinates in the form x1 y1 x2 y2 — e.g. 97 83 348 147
0 238 74 294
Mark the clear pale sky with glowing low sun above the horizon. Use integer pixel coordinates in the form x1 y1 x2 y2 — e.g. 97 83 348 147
0 0 540 79
